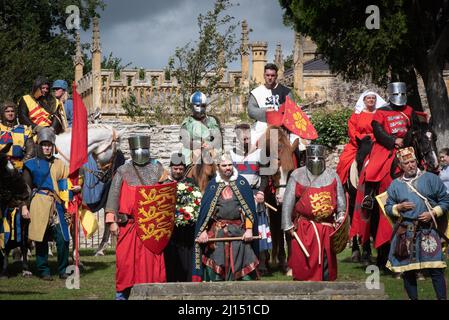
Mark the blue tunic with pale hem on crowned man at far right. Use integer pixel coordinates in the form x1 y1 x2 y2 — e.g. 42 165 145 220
385 172 449 272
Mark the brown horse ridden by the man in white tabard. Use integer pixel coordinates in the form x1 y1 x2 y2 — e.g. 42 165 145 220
259 126 299 273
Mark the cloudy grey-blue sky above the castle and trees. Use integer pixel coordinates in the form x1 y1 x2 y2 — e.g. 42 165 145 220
81 0 294 70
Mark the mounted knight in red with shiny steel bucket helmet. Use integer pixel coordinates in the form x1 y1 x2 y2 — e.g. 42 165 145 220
355 82 419 268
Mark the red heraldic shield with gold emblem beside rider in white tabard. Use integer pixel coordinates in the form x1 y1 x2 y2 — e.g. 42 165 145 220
283 96 318 140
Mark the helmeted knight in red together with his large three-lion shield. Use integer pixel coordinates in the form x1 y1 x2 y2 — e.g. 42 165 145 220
105 136 176 300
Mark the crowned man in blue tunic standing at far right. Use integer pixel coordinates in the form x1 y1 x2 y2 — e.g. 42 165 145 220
385 147 449 300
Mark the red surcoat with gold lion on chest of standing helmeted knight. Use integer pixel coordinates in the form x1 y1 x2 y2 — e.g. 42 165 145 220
288 180 337 281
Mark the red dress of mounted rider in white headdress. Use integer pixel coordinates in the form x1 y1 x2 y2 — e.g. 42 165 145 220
336 112 374 184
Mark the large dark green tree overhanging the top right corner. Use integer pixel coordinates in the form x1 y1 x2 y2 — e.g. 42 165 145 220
279 0 449 147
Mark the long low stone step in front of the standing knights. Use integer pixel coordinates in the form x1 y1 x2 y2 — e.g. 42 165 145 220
130 281 387 300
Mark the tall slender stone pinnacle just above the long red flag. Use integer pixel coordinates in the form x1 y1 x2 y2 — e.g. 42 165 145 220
89 17 104 112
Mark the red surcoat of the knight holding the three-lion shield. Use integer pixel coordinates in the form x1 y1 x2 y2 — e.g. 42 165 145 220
115 181 166 292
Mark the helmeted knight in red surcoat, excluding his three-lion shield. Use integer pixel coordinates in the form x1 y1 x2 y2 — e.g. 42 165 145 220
105 136 174 300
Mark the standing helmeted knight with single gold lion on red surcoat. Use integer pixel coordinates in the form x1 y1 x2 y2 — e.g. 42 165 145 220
281 145 349 281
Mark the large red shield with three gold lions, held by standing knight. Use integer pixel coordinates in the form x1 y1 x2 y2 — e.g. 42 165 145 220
134 182 177 254
